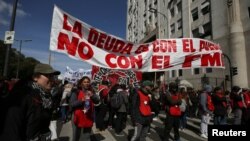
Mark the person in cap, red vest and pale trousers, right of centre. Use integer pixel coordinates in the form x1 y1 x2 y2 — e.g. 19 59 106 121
200 84 214 138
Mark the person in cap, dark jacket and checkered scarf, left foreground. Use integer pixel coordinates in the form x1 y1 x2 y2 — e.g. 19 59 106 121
0 63 60 141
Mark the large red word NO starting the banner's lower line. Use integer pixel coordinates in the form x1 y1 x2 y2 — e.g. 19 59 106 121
57 32 94 60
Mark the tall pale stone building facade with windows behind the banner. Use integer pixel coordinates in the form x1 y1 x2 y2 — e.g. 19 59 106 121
126 0 250 89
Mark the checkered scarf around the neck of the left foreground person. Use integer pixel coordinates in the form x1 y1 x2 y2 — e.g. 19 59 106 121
31 82 52 109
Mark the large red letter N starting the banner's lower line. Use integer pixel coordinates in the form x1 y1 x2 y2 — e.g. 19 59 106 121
57 32 79 56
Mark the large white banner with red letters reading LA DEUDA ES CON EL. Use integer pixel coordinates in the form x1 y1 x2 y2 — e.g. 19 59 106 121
50 6 225 72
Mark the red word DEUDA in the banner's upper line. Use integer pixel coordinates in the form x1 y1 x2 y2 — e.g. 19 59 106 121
88 28 133 54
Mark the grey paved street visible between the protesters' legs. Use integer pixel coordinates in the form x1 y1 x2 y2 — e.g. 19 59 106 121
58 114 206 141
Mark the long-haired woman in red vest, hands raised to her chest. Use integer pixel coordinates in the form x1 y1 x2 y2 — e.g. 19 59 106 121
70 76 99 141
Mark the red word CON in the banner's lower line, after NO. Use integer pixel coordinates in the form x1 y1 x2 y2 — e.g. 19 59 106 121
105 54 142 69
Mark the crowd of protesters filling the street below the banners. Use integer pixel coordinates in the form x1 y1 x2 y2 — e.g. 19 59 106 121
0 64 250 141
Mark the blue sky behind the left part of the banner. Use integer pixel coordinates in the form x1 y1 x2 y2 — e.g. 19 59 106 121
0 0 127 73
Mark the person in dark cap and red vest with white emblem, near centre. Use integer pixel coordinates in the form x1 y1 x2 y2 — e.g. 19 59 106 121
131 80 154 141
